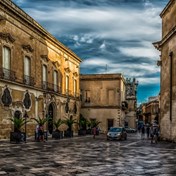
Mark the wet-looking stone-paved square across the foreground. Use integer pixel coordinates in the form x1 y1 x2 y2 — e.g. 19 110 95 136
0 134 176 176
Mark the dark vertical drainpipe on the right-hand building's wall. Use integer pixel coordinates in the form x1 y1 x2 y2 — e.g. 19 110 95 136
169 51 173 121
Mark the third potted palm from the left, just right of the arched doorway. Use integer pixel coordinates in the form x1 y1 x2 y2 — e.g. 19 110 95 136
52 119 64 139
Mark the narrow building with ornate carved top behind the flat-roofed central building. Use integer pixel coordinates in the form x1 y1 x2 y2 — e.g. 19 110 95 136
125 78 138 128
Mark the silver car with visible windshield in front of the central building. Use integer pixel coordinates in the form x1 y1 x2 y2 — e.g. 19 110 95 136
107 127 127 140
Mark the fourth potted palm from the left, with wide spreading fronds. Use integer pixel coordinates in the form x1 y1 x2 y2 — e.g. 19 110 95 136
63 117 77 137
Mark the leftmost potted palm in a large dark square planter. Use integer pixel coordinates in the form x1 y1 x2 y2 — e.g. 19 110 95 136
9 117 29 143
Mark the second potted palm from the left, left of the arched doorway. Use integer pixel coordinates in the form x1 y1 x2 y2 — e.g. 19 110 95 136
32 117 49 141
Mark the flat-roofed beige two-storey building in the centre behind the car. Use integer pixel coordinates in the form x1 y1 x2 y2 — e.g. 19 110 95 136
80 74 126 132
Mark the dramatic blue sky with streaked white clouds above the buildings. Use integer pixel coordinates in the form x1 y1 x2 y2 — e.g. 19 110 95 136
13 0 169 104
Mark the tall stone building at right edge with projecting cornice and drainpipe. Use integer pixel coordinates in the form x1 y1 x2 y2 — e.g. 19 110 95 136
153 0 176 141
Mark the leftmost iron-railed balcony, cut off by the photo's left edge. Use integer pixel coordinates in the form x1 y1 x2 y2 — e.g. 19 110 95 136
0 68 16 81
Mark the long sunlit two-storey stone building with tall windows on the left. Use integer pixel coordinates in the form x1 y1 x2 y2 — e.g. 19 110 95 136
0 0 81 138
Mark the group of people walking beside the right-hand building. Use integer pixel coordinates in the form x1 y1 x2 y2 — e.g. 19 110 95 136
138 123 159 144
